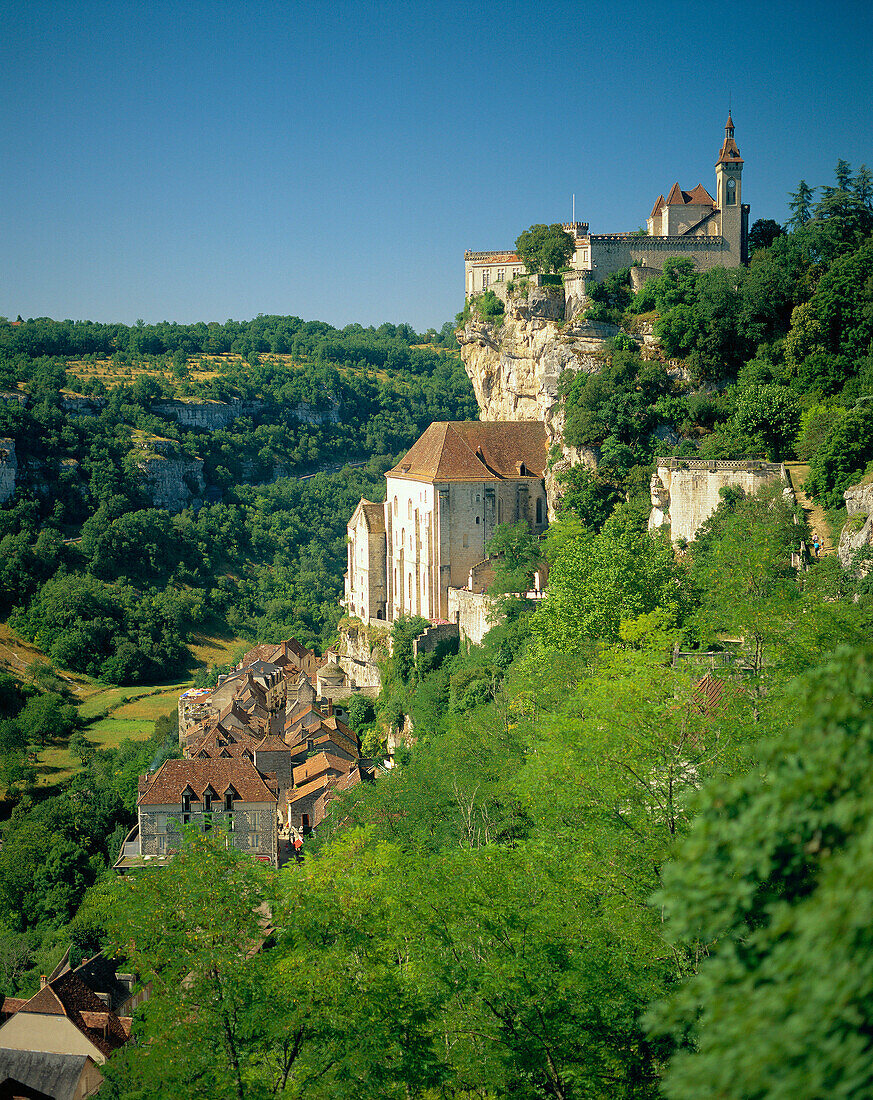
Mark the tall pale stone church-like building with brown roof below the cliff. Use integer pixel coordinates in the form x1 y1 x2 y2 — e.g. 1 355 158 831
345 420 548 623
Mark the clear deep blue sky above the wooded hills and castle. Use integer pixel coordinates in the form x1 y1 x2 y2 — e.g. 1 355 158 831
0 0 873 330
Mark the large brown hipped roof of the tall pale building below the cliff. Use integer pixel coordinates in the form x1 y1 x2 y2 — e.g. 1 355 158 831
386 420 546 482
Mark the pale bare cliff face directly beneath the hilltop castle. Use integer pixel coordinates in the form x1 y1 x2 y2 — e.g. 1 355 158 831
457 286 619 518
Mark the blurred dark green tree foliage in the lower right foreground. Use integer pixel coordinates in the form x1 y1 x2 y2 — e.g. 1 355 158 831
652 649 873 1100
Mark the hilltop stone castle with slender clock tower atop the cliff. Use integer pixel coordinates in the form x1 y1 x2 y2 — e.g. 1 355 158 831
464 114 749 301
